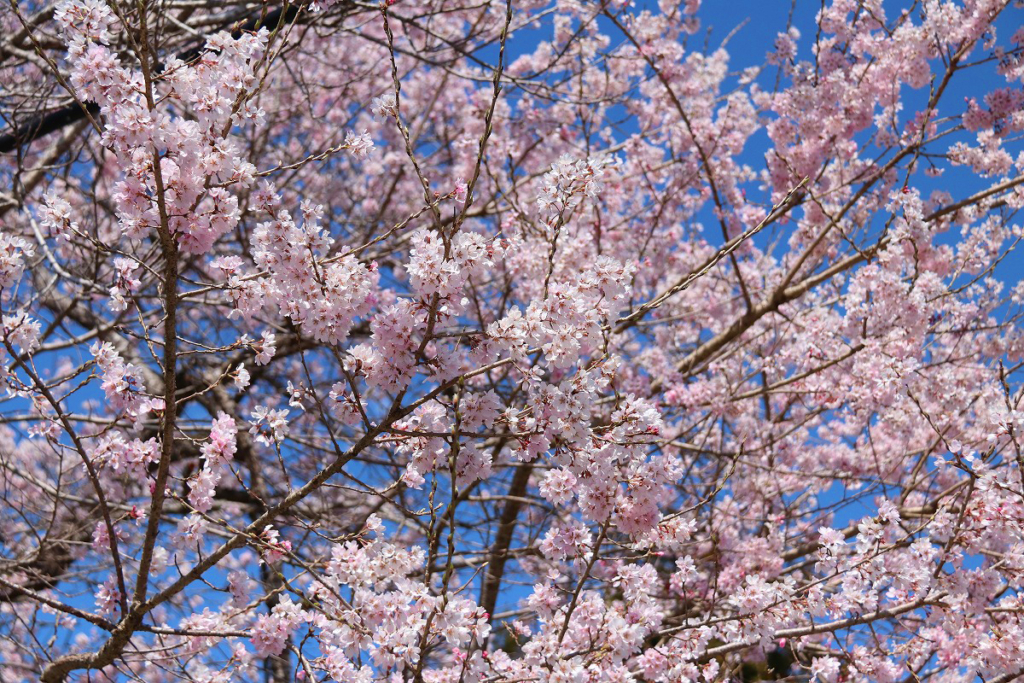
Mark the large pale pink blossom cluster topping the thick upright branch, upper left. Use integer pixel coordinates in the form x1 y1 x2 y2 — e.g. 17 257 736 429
55 0 267 254
